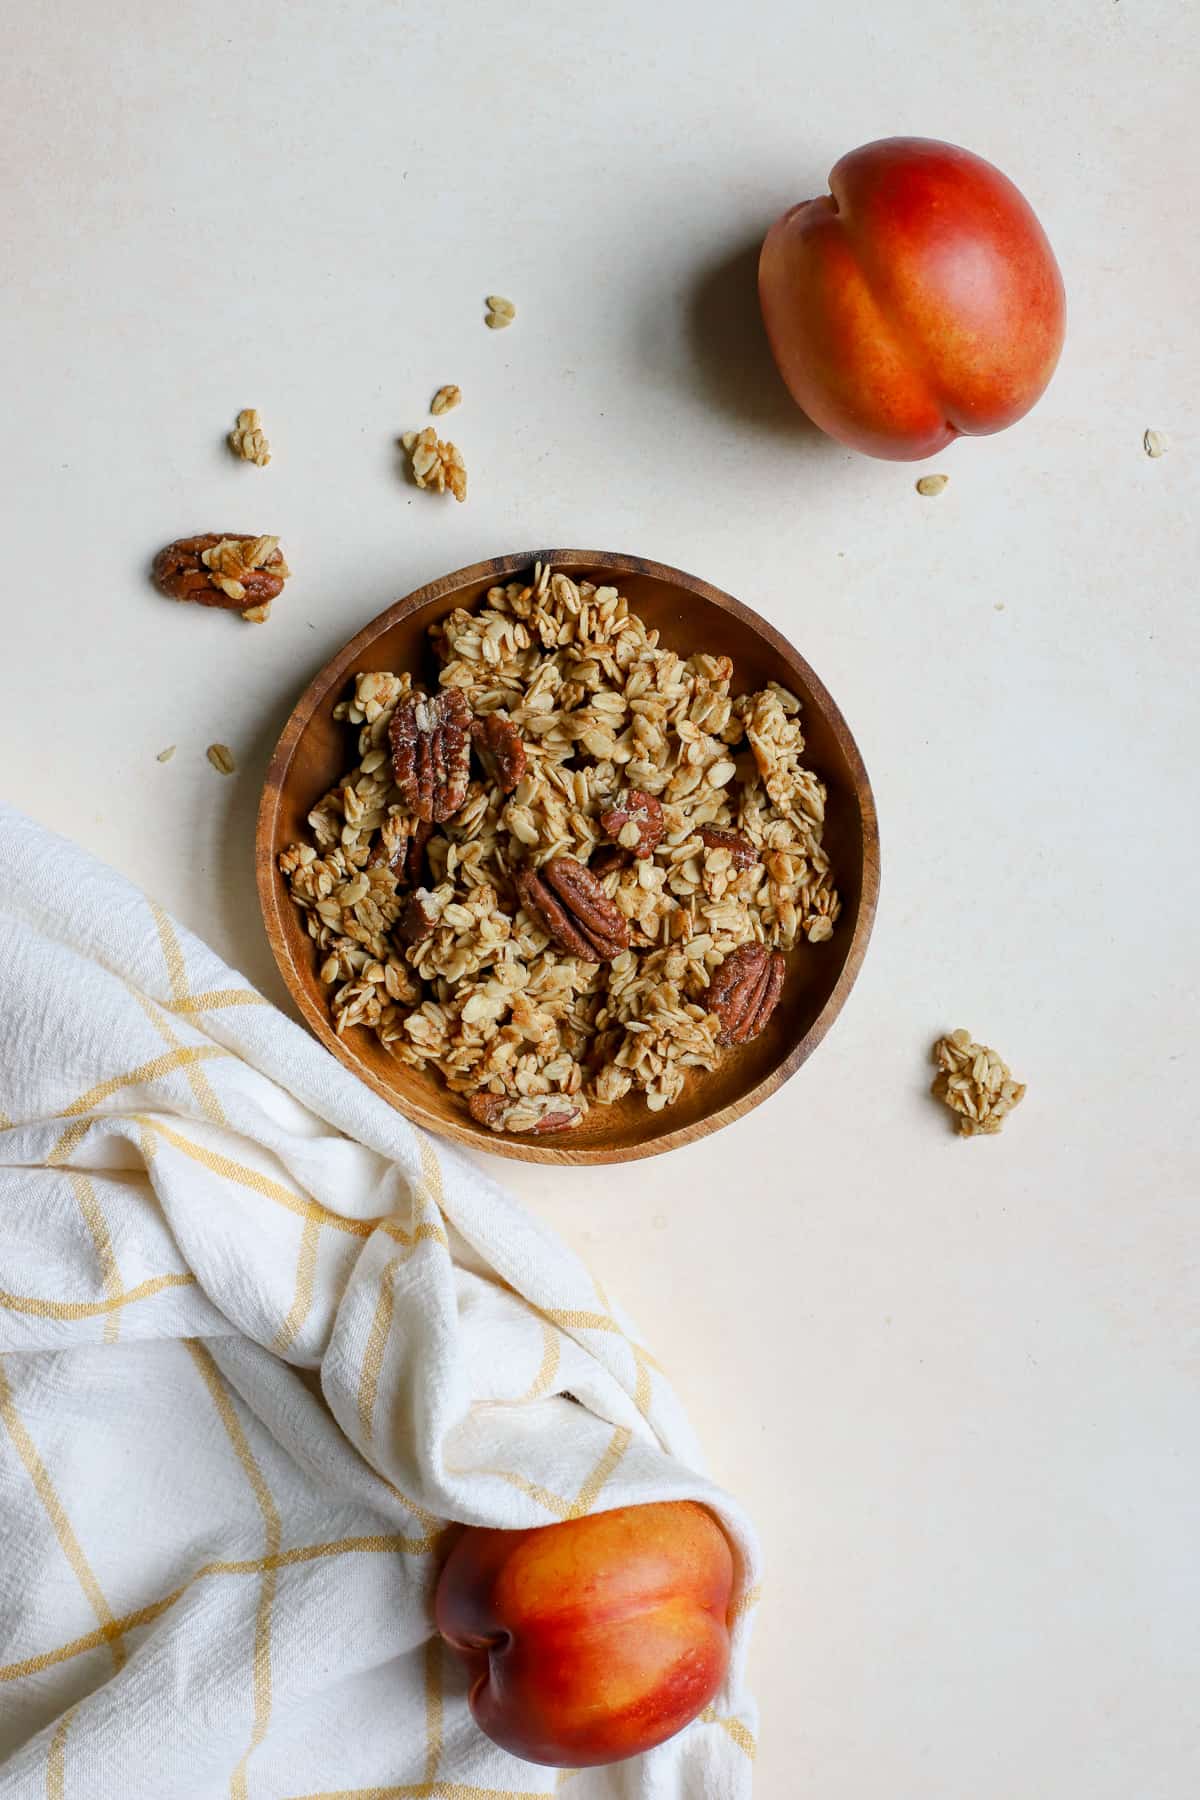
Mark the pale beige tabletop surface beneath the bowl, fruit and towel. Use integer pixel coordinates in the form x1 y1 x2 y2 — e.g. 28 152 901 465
0 0 1200 1800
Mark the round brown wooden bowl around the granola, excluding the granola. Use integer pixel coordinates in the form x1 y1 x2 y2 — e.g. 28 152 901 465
257 551 880 1163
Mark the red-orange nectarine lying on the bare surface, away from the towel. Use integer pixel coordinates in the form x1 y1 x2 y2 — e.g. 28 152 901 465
759 137 1065 461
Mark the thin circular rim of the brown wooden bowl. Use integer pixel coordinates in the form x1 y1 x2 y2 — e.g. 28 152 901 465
254 549 880 1166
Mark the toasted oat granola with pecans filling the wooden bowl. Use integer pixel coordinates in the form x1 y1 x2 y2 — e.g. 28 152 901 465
279 565 840 1136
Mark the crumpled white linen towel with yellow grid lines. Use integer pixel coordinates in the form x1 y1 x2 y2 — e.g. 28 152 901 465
0 810 757 1800
